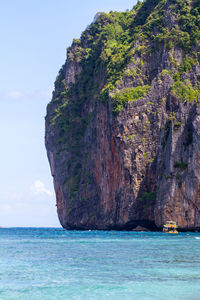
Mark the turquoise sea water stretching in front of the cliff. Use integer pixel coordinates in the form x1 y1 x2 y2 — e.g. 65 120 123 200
0 228 200 300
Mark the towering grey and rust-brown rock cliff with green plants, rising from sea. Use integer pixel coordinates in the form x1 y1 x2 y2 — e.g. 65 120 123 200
45 0 200 230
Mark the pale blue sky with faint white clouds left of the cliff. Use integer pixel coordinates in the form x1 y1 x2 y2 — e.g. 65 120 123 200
0 0 136 227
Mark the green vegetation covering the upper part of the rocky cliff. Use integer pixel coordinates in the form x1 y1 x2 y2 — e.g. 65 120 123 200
49 0 200 121
